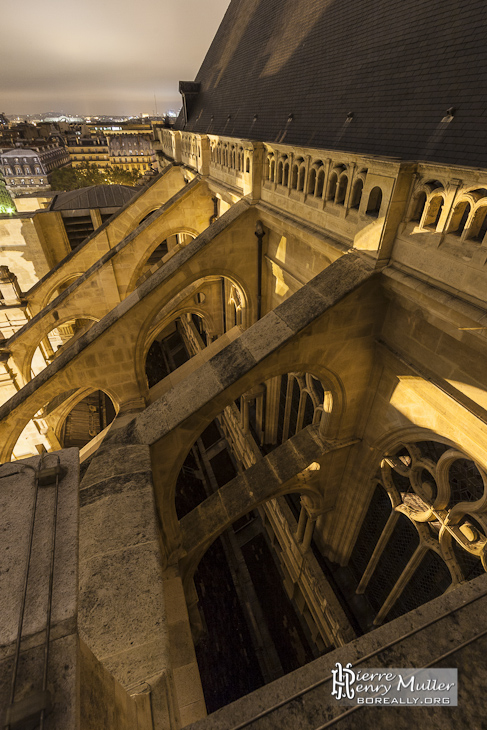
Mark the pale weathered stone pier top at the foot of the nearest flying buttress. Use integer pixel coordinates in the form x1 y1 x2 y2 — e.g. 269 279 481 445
79 442 179 729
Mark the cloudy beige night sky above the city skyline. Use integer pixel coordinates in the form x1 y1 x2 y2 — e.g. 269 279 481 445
0 0 229 115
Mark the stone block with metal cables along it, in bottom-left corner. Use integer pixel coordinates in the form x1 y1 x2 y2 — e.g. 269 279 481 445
0 449 152 730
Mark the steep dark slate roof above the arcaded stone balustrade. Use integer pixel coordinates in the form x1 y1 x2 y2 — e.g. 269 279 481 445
177 0 487 167
